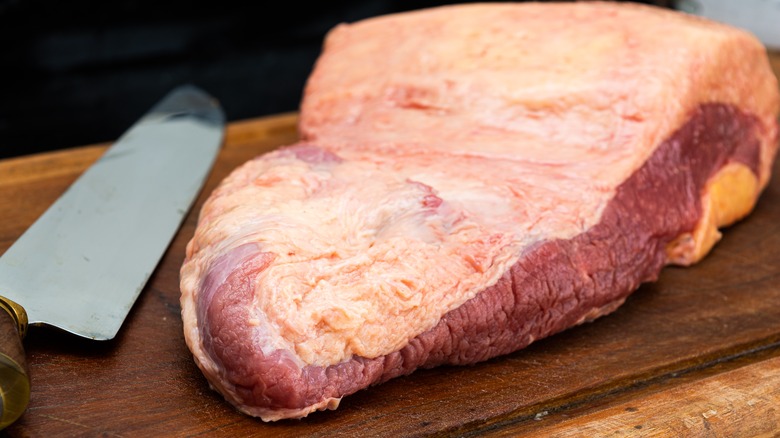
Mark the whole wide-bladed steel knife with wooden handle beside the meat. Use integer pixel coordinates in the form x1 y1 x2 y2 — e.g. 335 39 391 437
0 85 225 429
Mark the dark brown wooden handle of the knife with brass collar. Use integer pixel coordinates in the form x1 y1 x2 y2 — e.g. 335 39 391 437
0 296 30 430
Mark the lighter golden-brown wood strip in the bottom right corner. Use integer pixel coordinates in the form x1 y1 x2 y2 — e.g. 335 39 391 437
482 350 780 438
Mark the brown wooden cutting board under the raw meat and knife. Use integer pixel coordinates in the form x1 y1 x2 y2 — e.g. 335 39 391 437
0 56 780 437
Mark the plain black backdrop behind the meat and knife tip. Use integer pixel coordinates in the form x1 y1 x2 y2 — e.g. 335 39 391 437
0 0 663 158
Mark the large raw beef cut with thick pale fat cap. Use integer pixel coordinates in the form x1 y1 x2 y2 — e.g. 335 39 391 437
181 2 778 421
